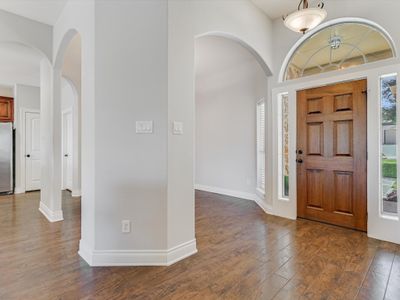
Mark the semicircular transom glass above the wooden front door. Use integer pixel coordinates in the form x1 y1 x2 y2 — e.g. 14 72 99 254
285 22 394 80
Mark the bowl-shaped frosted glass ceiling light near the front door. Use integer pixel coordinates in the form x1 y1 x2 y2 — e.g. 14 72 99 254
283 0 327 34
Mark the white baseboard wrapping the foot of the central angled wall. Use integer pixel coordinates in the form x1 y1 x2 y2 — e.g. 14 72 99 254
78 239 197 267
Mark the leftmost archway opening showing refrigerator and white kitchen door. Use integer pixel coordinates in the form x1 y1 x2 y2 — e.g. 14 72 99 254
0 41 50 197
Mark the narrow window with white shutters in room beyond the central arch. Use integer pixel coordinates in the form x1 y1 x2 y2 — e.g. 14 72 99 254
257 101 265 192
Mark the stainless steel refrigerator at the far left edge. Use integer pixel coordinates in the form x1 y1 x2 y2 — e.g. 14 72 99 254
0 123 14 194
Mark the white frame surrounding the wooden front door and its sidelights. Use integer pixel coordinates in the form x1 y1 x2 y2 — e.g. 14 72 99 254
269 64 400 243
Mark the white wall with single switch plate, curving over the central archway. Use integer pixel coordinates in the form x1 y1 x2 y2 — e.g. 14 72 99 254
167 0 272 247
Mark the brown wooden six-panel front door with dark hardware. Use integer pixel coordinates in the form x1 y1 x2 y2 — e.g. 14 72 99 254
296 80 367 231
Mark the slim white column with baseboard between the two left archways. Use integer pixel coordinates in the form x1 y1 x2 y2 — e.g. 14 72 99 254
39 59 63 222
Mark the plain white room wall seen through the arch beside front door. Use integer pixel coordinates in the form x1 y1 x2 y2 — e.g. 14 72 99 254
195 37 267 198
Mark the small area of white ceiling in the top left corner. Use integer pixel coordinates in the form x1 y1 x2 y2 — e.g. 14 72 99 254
0 0 67 25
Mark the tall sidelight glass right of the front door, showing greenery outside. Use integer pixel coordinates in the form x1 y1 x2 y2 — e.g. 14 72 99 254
380 74 398 215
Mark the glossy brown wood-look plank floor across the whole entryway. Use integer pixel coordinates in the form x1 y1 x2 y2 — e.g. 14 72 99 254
0 192 400 300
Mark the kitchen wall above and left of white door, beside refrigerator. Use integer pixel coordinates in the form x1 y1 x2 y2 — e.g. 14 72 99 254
14 84 40 193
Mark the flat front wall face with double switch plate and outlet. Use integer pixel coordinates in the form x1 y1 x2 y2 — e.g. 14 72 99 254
94 0 167 250
